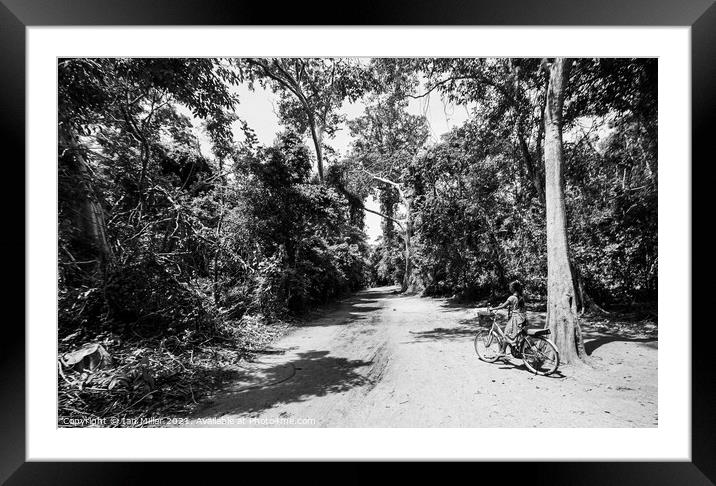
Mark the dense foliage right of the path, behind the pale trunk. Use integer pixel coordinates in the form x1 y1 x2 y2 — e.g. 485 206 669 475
356 59 657 308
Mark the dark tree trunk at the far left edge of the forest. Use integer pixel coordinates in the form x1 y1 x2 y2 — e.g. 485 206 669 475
59 124 112 271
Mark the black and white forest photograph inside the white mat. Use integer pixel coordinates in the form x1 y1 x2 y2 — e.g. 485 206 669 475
58 57 659 428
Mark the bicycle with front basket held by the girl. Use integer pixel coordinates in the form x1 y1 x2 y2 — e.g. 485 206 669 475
475 310 559 376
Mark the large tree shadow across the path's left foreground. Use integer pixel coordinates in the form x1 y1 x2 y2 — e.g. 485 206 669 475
194 351 373 418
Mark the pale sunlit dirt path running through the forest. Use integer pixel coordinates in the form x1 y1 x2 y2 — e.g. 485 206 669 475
183 288 657 427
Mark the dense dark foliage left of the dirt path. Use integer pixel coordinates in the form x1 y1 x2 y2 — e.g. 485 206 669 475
59 59 367 338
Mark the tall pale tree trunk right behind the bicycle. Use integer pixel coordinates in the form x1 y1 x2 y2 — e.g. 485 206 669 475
544 58 585 363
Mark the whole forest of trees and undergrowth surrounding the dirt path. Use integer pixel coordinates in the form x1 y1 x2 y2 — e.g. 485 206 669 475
57 58 658 417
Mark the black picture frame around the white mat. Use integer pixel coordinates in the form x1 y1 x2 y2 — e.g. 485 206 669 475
0 0 716 485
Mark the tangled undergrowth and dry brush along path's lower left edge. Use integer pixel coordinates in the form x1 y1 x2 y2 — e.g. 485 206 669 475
58 317 289 427
